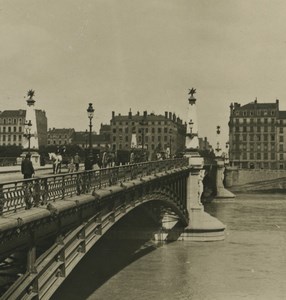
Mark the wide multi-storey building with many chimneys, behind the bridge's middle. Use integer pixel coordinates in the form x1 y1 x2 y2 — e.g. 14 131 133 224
110 111 186 159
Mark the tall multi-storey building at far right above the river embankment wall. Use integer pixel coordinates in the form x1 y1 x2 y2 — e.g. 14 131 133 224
229 100 286 169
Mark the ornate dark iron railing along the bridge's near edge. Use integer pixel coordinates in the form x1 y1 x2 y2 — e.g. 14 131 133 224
0 158 188 215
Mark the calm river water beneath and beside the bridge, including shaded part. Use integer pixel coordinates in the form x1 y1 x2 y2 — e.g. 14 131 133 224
53 194 286 300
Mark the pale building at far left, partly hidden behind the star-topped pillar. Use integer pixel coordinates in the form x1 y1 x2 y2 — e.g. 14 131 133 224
0 109 47 146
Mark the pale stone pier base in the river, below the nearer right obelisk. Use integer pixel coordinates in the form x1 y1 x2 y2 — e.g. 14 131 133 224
179 152 225 241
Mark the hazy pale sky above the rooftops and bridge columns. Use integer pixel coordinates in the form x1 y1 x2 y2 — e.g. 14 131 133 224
0 0 286 145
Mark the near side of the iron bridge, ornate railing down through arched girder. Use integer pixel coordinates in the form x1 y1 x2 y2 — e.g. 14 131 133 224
0 159 191 299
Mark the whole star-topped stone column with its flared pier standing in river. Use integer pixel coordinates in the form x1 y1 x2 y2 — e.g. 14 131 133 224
179 88 225 241
